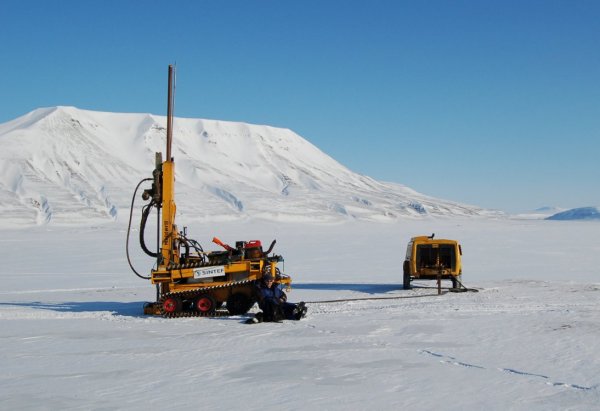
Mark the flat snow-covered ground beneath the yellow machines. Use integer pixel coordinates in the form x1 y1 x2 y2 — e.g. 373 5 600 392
0 218 600 410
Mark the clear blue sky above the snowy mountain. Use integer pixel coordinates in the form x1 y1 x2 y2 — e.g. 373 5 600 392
0 0 600 212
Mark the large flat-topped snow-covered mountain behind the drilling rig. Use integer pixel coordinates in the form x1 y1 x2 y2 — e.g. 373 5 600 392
0 107 497 227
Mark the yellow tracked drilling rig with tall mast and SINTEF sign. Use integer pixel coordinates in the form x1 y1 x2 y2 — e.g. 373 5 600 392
127 65 292 318
